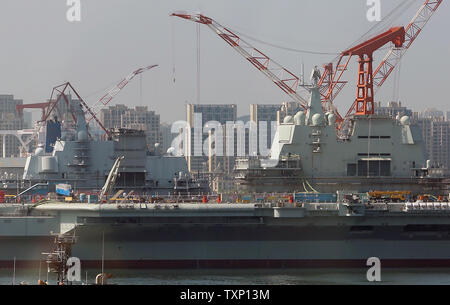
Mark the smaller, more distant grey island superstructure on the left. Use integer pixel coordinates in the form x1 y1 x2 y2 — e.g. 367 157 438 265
13 103 208 194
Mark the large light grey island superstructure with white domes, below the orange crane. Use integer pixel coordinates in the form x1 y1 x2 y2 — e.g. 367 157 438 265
235 87 447 194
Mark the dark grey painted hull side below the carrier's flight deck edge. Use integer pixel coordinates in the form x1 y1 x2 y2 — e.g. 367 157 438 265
4 214 450 268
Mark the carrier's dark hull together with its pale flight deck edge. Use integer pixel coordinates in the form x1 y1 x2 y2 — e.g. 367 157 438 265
4 204 450 269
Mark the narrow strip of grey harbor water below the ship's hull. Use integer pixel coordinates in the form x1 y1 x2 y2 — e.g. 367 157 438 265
0 267 450 285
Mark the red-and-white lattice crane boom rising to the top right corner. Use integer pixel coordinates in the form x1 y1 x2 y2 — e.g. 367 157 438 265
373 0 442 92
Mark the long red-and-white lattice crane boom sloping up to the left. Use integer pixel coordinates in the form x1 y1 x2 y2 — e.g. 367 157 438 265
171 13 308 110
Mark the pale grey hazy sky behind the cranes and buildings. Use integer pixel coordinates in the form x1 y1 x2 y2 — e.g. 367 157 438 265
0 0 450 121
